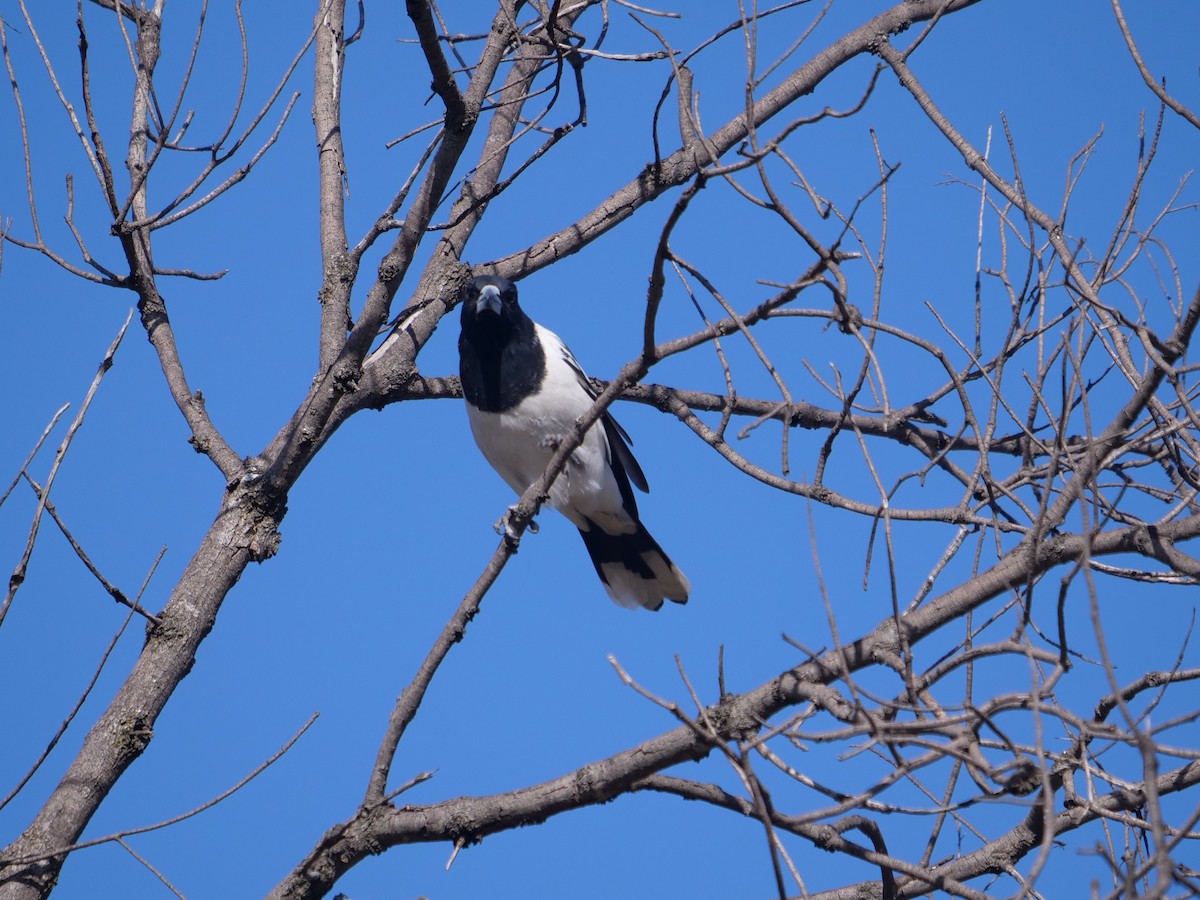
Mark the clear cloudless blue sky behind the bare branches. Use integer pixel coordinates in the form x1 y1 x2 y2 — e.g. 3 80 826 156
0 0 1200 900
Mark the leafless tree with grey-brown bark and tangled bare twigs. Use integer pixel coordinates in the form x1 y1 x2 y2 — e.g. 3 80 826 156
0 0 1200 899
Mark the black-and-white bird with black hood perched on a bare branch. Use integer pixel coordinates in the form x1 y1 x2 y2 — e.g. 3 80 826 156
458 275 691 610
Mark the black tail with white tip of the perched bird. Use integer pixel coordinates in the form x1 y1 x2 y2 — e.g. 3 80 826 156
580 520 691 610
